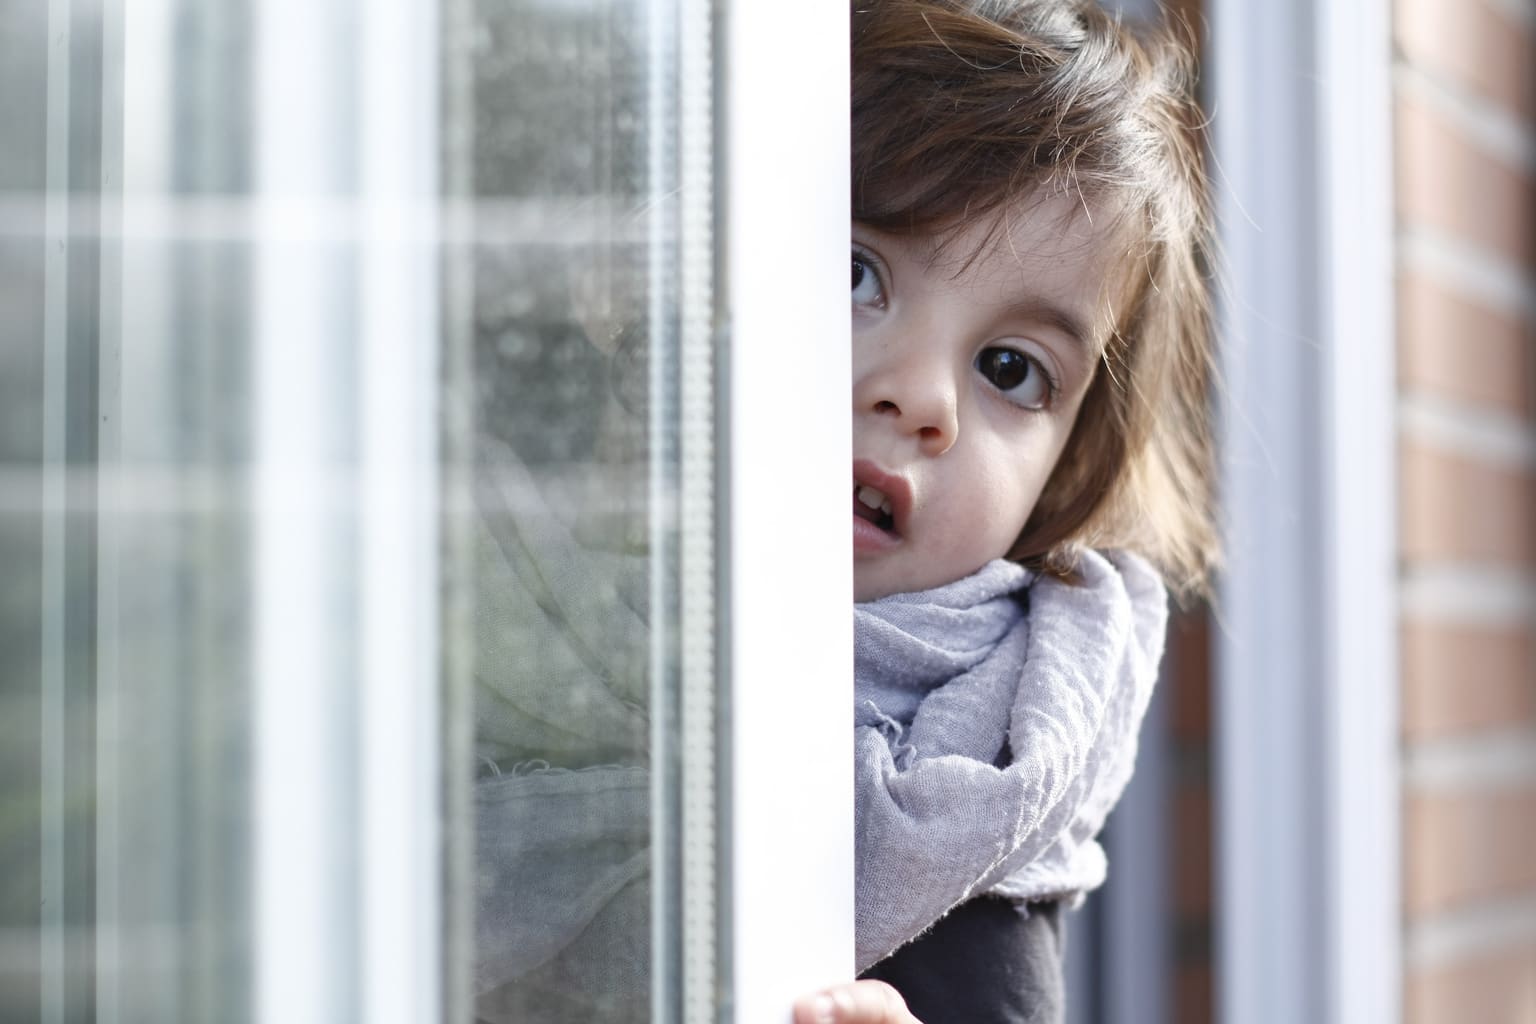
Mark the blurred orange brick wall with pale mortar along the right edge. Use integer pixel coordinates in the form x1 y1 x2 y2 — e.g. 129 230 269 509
1393 0 1536 1024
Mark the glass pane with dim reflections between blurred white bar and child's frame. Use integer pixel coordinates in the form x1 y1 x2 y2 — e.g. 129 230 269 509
445 0 713 1022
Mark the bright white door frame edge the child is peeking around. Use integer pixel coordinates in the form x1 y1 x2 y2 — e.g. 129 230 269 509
719 0 852 1024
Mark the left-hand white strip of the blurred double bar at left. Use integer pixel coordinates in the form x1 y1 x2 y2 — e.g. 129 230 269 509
252 0 358 1024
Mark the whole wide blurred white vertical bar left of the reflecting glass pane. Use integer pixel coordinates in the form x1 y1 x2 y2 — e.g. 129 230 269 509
252 0 444 1024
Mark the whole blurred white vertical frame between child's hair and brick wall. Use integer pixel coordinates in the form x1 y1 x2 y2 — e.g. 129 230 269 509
1210 0 1401 1024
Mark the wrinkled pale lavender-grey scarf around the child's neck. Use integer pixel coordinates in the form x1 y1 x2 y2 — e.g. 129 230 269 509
854 551 1167 970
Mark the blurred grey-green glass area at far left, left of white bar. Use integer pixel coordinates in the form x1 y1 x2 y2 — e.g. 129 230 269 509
0 3 252 1021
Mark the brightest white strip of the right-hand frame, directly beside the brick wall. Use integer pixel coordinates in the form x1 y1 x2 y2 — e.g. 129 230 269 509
1316 0 1402 1022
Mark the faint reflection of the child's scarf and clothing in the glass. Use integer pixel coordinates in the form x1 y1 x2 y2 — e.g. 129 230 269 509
473 439 651 1024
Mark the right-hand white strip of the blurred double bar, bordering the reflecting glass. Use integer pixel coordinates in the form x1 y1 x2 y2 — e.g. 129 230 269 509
356 0 445 1024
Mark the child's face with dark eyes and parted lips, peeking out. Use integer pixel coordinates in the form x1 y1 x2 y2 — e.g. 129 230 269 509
852 195 1126 600
